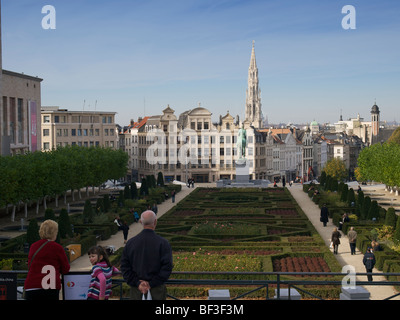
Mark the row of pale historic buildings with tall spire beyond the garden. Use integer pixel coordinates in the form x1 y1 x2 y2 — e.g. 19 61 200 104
120 42 388 182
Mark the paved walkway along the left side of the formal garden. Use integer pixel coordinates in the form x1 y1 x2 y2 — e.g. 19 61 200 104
71 183 206 271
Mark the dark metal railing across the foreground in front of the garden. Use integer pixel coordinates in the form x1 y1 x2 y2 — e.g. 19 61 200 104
6 271 400 300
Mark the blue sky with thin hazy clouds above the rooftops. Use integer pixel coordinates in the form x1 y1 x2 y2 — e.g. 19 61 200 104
1 0 400 126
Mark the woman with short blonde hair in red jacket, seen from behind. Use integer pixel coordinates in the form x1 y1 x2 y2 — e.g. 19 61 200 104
24 220 70 300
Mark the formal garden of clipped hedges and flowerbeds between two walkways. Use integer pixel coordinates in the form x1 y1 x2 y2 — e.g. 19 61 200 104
113 188 341 299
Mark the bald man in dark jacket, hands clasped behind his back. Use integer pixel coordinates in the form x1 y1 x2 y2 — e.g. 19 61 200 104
121 210 172 300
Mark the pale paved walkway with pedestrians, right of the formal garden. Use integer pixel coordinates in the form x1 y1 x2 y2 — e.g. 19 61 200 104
288 184 400 300
